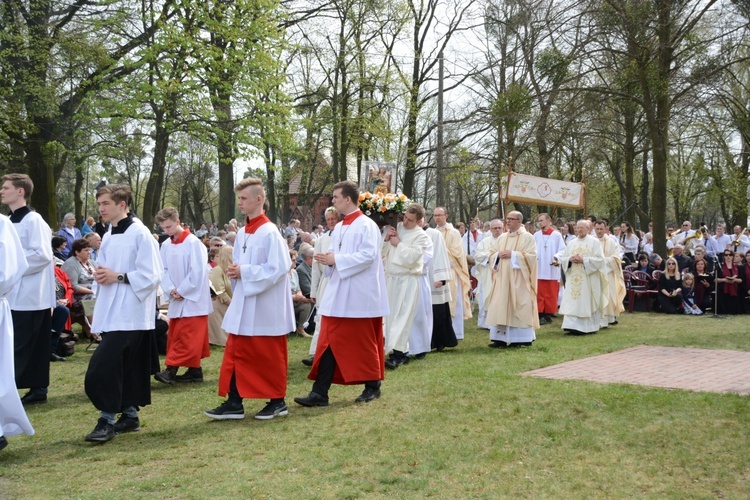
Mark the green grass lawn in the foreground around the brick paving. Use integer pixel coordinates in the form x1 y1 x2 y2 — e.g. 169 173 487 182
0 313 750 498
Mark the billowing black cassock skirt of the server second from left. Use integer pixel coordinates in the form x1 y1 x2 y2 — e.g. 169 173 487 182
84 330 152 413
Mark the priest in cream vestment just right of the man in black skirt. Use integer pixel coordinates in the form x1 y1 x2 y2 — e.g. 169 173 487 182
432 207 471 340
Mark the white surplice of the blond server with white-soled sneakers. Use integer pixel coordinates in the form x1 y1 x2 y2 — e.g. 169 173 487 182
221 222 296 337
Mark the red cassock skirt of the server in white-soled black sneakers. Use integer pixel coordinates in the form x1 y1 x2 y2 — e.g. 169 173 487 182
219 333 289 399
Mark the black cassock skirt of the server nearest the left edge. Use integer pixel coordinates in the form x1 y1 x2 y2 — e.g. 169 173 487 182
11 309 52 389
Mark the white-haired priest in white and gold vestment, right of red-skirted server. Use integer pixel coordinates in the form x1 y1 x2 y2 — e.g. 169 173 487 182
560 220 607 335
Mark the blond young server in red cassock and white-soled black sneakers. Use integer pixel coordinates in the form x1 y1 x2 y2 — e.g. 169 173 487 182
209 177 295 420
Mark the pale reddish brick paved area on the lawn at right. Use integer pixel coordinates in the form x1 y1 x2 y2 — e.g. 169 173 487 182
524 345 750 395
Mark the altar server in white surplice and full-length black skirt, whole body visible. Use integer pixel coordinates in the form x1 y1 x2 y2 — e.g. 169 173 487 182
85 184 164 443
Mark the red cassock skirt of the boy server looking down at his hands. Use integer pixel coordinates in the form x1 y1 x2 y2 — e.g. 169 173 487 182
164 316 211 368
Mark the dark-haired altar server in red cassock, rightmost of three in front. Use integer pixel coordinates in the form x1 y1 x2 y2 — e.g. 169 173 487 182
294 181 389 406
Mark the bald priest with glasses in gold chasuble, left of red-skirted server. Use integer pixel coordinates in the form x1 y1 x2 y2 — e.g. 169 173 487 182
487 211 539 347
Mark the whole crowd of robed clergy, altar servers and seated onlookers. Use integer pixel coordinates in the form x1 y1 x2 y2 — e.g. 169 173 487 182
0 174 750 449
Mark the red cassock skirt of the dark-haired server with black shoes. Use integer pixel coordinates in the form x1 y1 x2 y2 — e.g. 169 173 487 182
307 316 385 385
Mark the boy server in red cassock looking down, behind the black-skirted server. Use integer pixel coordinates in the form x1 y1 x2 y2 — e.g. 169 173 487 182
154 207 213 384
